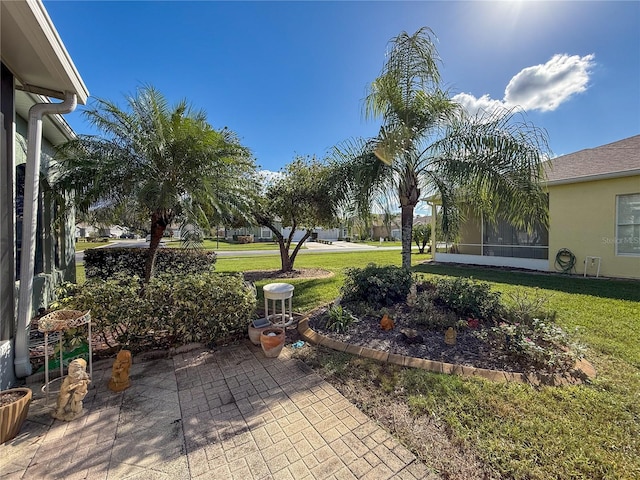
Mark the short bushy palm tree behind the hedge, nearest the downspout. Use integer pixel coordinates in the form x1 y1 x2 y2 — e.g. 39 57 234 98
56 86 255 282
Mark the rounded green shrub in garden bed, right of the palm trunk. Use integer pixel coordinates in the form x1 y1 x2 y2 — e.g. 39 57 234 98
435 277 502 322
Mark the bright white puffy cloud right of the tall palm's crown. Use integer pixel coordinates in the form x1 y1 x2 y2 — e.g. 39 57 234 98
453 54 595 114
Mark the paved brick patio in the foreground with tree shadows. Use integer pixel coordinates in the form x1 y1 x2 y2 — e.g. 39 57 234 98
0 342 437 480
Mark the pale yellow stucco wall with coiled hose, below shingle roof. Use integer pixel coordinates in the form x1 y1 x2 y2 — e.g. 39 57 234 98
549 175 640 278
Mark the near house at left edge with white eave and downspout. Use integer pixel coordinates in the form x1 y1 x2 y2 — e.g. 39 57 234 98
0 0 89 389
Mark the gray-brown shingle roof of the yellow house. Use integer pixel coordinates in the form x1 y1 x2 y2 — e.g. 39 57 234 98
545 135 640 185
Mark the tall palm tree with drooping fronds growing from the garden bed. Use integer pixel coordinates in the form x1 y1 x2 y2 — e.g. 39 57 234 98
334 27 548 268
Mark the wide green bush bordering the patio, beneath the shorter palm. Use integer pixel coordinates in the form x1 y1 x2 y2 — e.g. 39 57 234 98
51 272 256 350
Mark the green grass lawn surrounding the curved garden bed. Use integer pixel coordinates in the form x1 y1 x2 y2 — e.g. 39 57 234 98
76 251 640 479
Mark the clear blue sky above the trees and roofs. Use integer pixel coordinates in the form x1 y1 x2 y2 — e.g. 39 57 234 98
44 0 640 177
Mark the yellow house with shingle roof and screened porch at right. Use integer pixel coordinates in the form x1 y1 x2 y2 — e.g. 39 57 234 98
435 135 640 278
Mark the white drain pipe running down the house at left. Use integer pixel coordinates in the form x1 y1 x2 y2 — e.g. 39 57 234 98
14 92 77 378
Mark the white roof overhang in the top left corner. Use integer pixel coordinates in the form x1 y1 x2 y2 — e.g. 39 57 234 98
0 0 89 105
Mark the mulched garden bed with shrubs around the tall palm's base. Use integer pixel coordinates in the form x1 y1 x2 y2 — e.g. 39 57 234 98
308 264 592 383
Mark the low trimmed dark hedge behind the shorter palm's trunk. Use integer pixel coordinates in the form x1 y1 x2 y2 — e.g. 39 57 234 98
84 248 216 280
